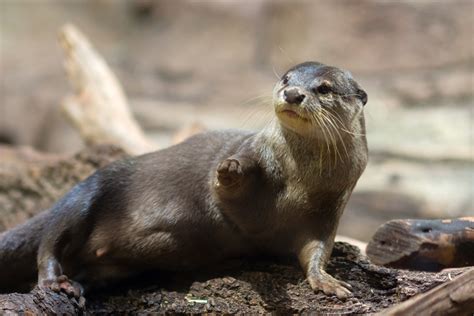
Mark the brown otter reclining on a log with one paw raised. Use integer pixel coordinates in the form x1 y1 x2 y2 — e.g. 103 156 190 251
0 62 368 298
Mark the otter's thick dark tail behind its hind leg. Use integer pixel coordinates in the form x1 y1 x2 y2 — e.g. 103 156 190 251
0 211 52 293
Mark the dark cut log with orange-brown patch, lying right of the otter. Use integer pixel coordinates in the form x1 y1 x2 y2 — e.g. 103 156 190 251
367 217 474 271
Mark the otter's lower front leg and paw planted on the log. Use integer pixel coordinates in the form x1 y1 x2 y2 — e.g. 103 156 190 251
298 238 351 299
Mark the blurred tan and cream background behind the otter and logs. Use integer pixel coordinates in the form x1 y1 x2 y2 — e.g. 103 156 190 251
0 0 474 240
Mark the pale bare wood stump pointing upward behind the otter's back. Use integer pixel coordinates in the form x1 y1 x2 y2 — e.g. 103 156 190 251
59 25 157 154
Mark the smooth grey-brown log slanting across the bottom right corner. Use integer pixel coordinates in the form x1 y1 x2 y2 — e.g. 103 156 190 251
380 269 474 316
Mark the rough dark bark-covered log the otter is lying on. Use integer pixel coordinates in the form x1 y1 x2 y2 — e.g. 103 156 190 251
0 243 468 314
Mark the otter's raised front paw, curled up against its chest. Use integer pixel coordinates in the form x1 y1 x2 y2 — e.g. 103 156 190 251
215 155 258 198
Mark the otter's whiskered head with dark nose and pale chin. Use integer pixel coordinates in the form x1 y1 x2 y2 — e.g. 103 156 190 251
273 62 367 136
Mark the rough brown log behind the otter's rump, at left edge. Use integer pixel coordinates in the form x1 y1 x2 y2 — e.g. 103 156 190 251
0 145 127 232
